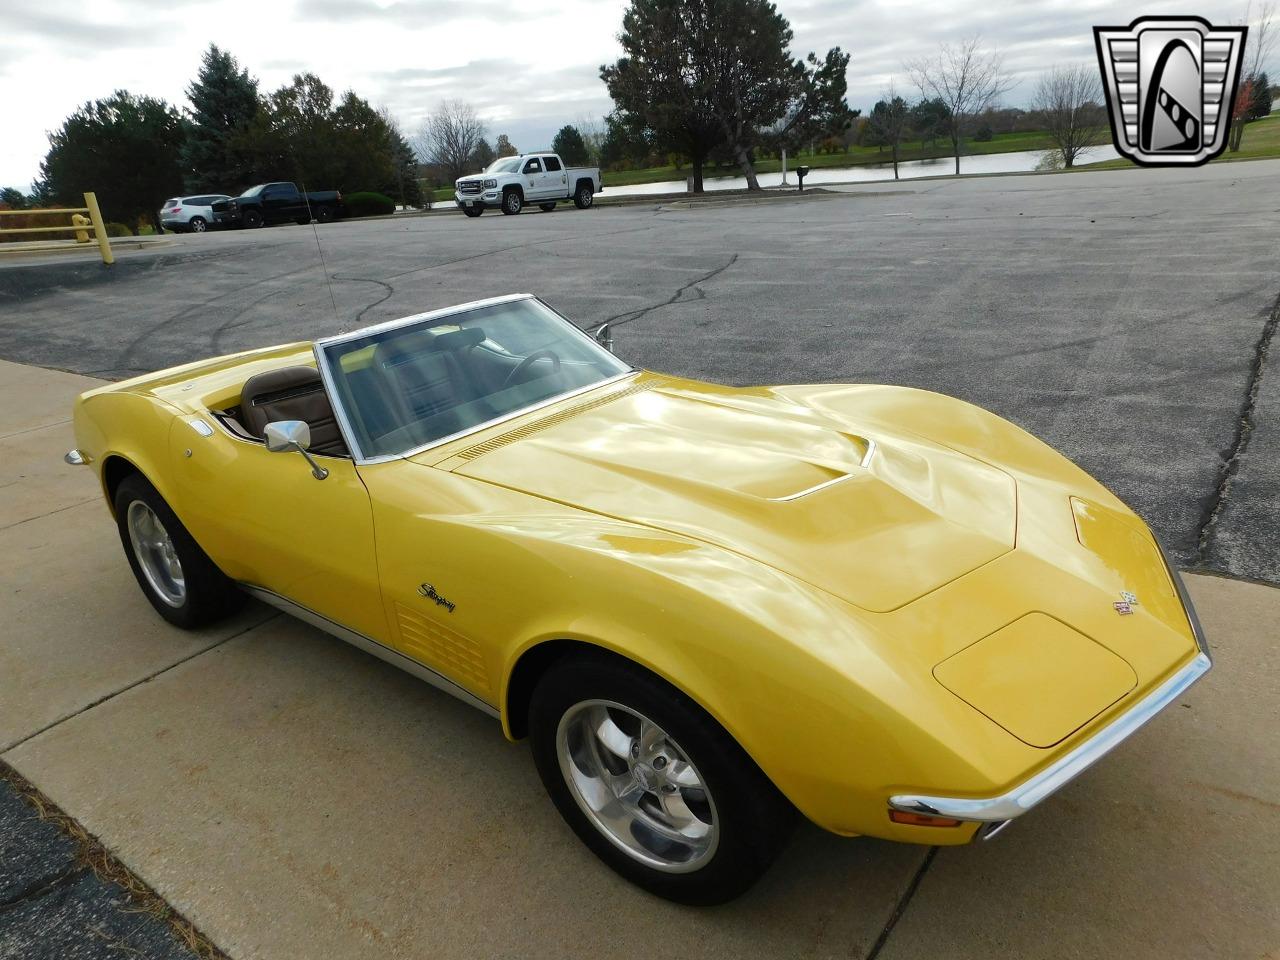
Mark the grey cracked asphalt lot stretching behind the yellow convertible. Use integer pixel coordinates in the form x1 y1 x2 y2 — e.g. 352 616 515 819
0 161 1280 582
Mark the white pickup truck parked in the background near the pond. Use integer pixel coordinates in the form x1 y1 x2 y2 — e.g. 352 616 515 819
453 154 604 216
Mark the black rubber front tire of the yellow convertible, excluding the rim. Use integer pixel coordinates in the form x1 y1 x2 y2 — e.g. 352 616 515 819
529 654 796 905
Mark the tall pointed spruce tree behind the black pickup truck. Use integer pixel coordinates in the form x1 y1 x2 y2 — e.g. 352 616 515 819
182 44 262 193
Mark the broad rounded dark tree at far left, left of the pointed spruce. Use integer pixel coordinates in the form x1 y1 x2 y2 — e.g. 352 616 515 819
40 90 183 232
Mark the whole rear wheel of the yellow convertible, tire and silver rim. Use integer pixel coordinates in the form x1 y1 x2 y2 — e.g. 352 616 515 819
115 474 244 630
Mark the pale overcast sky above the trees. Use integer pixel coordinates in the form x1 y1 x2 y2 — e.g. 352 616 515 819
0 0 1259 188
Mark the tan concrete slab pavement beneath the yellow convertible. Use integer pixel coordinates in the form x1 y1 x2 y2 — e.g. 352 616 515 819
0 362 1280 960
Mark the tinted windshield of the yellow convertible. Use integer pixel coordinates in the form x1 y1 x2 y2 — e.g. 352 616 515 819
321 298 631 458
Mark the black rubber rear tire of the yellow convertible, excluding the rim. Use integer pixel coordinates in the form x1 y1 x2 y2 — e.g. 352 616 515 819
115 474 244 630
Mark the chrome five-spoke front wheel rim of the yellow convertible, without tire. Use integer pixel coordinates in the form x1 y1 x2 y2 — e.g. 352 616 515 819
556 700 719 873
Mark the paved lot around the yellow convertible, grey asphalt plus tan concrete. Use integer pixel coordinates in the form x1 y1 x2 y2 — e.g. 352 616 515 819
0 161 1280 957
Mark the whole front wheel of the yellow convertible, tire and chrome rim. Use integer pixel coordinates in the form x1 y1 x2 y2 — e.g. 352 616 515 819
529 655 795 905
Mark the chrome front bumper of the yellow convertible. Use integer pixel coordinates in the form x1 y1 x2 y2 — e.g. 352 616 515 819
888 549 1213 838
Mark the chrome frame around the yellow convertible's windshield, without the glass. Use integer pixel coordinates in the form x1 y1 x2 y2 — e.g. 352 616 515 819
311 293 640 466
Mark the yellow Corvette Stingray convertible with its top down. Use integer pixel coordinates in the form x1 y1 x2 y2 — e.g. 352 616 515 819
67 296 1210 904
